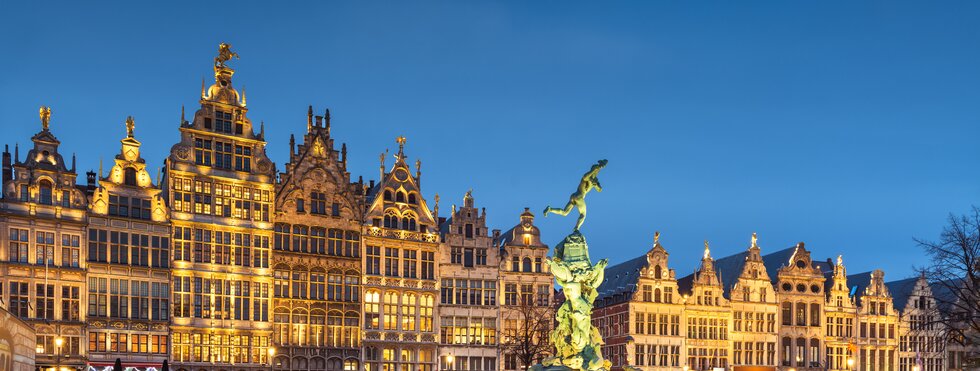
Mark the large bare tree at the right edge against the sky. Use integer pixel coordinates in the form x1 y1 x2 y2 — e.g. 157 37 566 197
916 207 980 354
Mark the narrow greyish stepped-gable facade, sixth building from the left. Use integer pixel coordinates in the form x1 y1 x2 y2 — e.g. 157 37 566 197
439 192 500 371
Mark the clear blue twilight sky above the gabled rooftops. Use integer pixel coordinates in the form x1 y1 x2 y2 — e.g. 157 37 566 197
0 1 980 279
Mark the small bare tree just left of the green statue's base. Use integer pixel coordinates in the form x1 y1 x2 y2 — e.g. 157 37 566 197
501 297 555 370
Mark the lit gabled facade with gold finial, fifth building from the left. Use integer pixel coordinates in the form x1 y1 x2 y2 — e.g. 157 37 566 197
362 137 440 371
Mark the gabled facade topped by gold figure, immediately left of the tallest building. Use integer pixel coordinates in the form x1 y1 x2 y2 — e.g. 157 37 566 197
85 117 171 370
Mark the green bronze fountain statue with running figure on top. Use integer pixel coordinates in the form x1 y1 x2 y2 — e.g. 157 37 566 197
531 160 611 371
